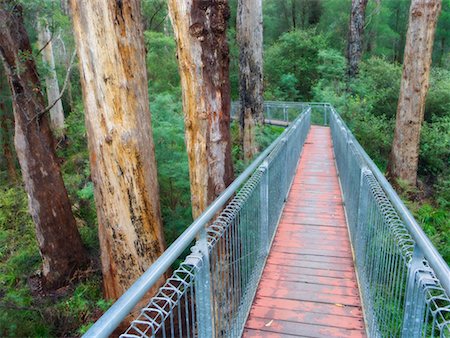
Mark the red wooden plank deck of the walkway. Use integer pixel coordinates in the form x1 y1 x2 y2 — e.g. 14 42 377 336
243 126 365 337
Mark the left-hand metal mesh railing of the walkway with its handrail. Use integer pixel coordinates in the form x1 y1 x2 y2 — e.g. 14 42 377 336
85 106 311 338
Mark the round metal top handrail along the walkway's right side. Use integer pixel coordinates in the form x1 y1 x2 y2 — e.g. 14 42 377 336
326 104 450 295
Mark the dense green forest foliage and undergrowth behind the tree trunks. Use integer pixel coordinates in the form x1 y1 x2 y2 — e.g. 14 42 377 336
0 0 450 336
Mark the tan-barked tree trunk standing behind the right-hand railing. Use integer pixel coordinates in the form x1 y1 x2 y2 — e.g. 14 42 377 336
388 0 441 185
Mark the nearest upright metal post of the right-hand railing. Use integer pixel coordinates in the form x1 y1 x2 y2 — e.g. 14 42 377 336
402 244 424 338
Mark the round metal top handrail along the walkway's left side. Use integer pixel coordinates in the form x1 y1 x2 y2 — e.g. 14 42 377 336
83 108 310 337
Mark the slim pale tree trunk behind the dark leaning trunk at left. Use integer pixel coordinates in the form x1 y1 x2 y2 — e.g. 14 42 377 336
38 19 64 138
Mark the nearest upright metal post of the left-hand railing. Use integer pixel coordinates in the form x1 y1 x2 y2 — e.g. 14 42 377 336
195 227 216 338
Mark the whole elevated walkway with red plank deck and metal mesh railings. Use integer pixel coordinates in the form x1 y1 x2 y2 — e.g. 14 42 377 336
85 102 450 338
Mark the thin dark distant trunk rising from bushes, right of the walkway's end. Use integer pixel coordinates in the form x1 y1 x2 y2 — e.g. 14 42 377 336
347 0 368 79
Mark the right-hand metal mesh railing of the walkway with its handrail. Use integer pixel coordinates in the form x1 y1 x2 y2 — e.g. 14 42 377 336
324 104 450 337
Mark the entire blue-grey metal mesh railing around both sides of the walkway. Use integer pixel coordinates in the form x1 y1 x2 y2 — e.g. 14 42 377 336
82 102 450 338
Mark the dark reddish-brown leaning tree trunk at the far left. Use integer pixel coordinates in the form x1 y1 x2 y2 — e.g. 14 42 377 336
0 1 87 288
